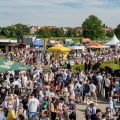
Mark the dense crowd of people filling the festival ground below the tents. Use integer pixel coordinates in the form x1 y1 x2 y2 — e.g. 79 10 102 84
0 48 120 120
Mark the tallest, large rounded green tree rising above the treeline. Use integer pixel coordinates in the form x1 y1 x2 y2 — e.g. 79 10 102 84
82 15 104 39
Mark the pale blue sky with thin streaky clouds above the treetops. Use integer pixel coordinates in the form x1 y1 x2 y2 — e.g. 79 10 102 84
0 0 120 27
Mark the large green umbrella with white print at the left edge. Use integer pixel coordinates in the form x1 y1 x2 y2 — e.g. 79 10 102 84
0 59 32 72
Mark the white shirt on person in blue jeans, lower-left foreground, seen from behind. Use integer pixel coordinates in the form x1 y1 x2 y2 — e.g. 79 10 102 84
28 98 39 112
